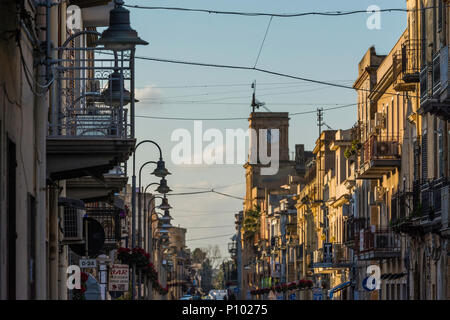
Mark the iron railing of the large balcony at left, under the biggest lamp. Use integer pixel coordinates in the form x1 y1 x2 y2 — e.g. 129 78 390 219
48 39 135 138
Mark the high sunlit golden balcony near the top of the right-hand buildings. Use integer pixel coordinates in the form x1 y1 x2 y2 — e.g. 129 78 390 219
393 40 420 91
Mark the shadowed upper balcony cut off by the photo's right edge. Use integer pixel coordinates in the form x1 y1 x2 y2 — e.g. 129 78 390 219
419 46 450 120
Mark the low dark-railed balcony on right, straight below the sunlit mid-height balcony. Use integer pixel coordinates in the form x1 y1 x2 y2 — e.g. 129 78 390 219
355 228 401 260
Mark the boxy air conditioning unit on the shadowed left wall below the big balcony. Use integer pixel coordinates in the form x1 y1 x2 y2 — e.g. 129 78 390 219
59 198 86 244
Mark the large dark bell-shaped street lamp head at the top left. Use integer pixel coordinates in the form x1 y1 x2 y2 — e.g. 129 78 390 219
96 0 148 51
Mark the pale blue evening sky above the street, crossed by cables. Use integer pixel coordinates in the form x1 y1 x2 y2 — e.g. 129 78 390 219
125 0 406 258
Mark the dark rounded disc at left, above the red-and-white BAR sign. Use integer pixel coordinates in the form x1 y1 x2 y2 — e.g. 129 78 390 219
69 218 105 258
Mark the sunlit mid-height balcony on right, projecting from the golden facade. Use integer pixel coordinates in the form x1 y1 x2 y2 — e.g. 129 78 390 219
357 134 401 179
